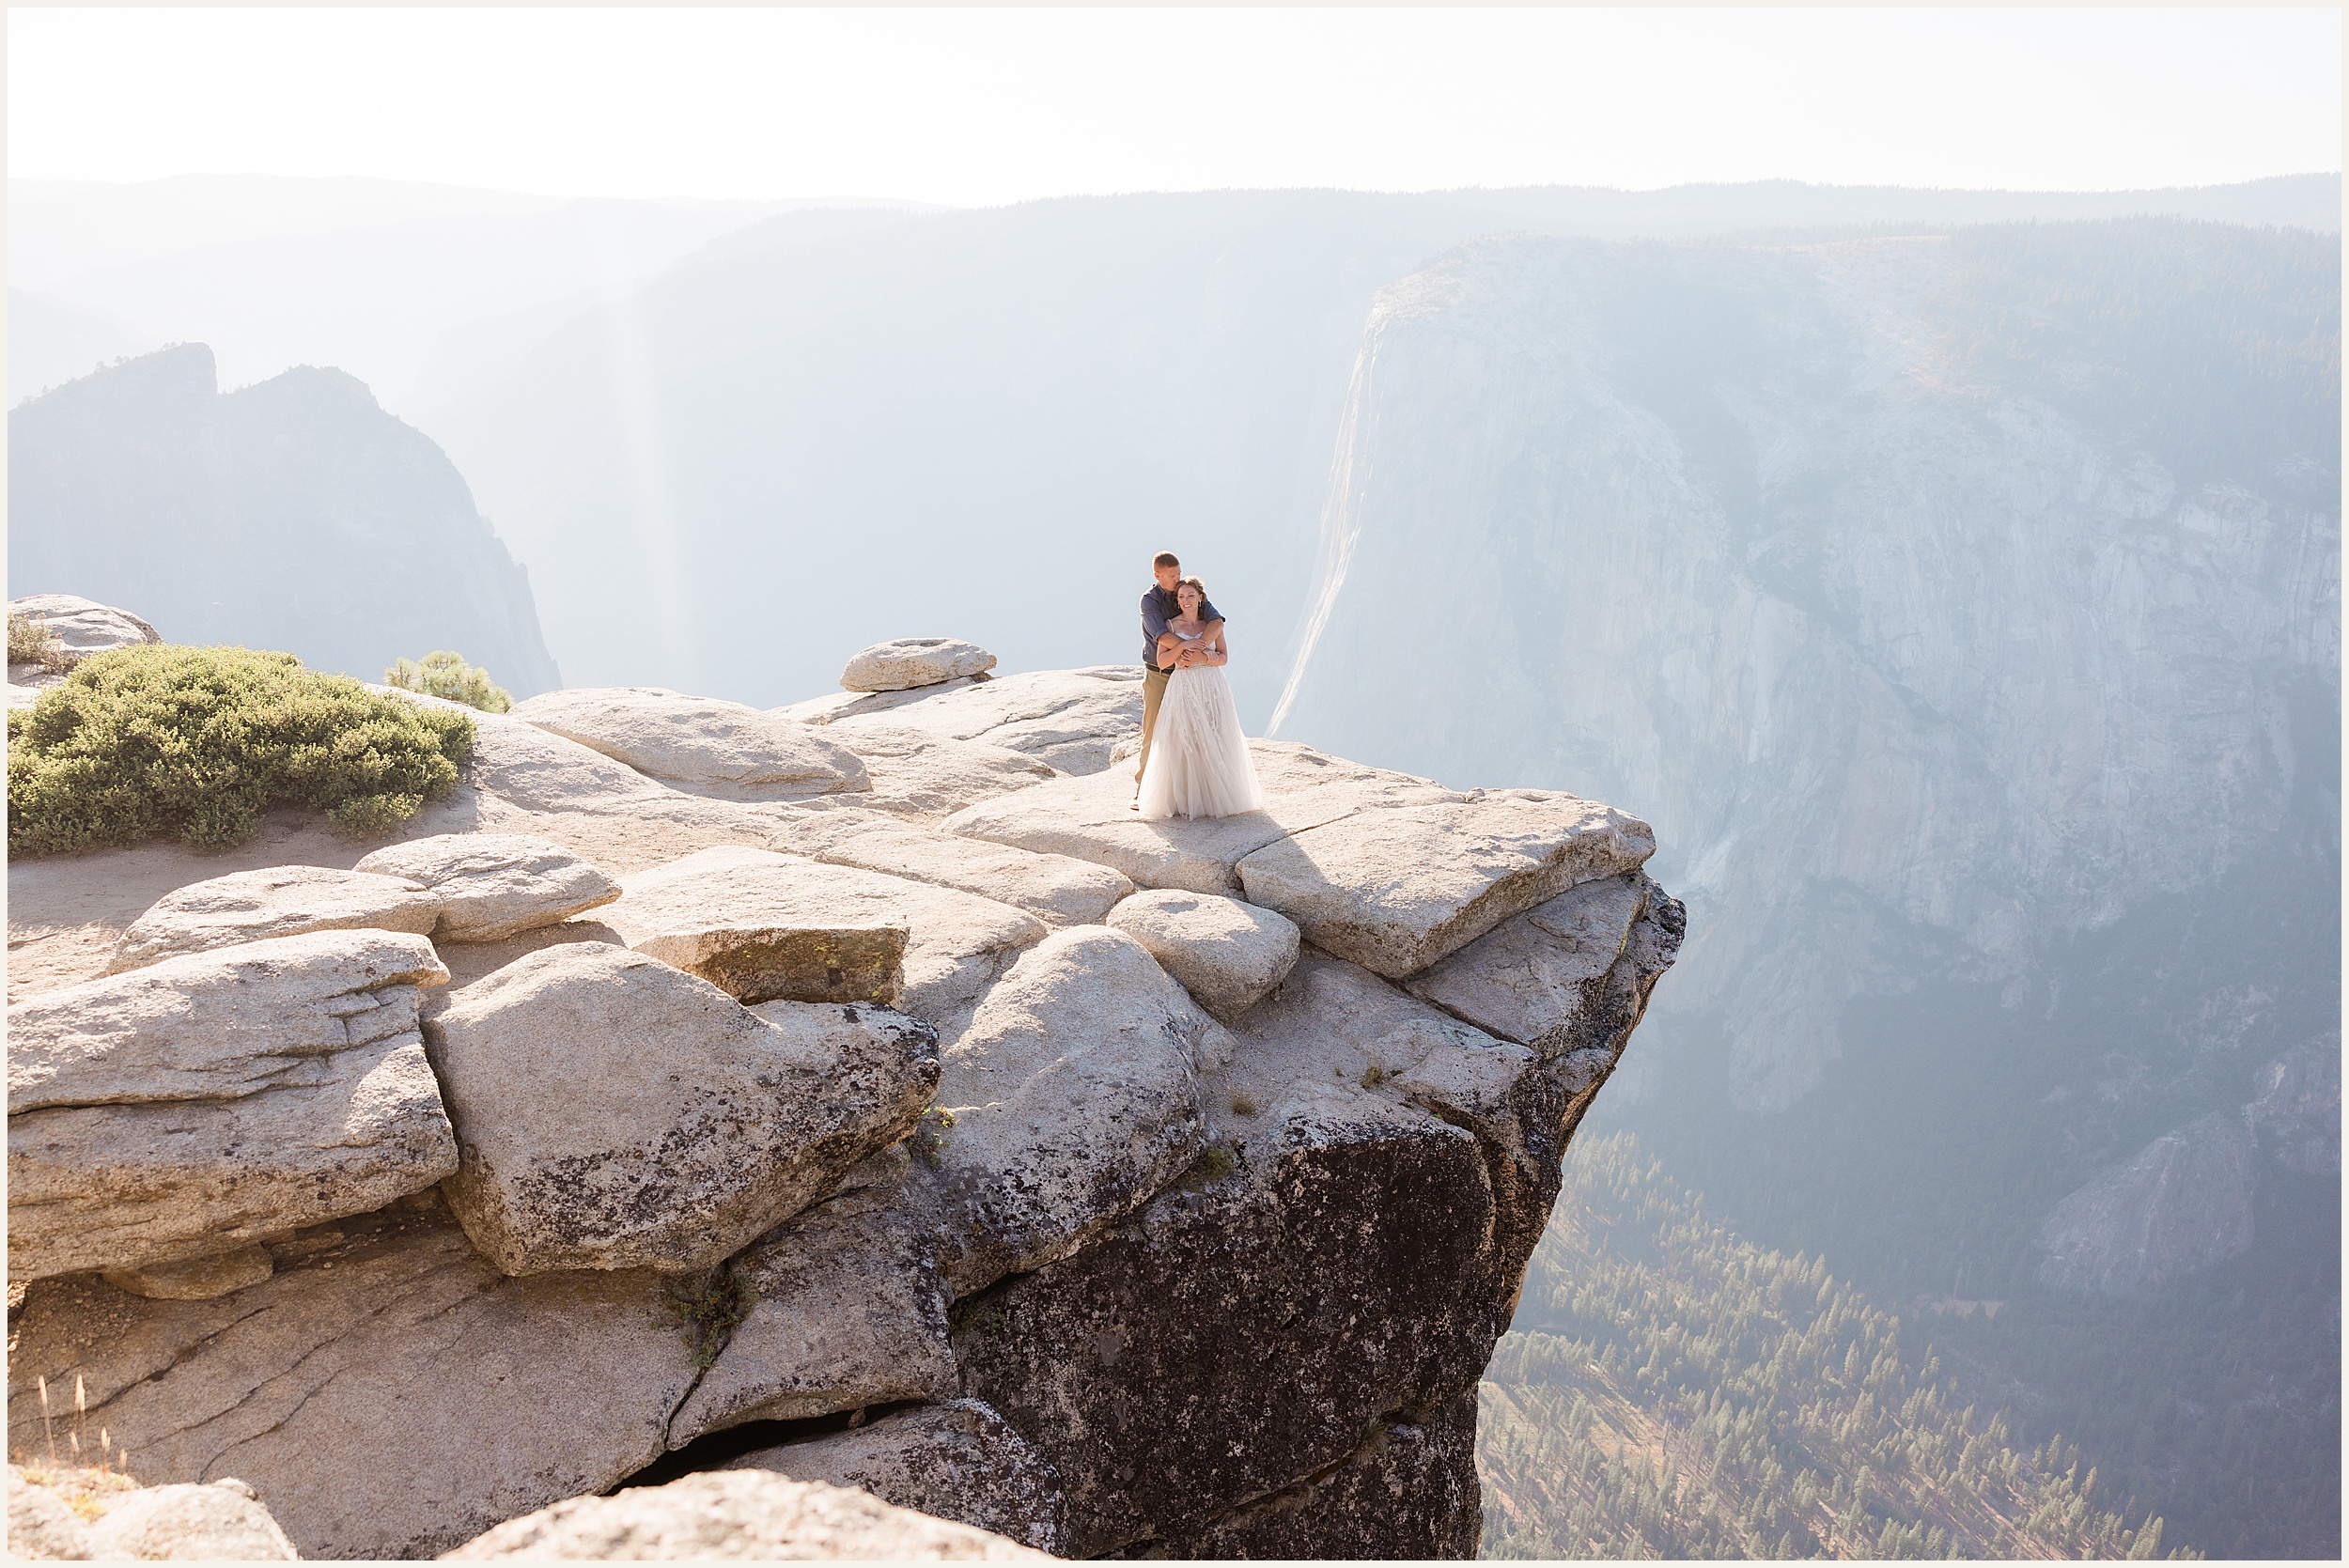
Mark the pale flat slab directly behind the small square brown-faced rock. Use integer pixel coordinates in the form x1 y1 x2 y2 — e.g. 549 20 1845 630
601 845 1046 1023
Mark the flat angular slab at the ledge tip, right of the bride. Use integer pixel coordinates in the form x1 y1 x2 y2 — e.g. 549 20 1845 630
1231 788 1657 979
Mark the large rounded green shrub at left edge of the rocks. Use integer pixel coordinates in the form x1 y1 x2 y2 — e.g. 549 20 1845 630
8 644 473 854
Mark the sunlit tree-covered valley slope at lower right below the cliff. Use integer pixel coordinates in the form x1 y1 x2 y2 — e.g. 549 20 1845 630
1478 1134 2199 1559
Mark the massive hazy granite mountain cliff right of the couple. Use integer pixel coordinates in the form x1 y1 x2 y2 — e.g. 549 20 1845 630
1271 223 2340 1557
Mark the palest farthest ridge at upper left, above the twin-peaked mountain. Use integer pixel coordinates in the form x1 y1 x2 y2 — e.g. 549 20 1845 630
9 176 944 420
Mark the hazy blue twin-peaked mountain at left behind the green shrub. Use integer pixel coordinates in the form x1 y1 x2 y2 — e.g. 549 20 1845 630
9 343 559 695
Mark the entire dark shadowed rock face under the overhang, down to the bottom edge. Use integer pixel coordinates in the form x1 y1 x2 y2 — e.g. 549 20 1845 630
954 894 1685 1557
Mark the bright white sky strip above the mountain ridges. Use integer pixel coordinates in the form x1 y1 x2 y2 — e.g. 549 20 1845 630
8 7 2342 204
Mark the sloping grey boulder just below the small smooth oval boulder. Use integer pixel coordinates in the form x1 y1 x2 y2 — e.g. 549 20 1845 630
914 924 1231 1296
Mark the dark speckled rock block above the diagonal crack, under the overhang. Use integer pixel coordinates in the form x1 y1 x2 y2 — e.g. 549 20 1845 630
954 1117 1506 1557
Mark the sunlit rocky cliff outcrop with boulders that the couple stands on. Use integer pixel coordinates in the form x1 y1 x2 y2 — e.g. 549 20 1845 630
9 633 1685 1557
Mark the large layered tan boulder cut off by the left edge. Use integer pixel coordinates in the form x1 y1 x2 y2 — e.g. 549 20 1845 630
8 932 456 1280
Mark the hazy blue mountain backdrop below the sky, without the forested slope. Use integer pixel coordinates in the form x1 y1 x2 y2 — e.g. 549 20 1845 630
9 174 2342 1557
